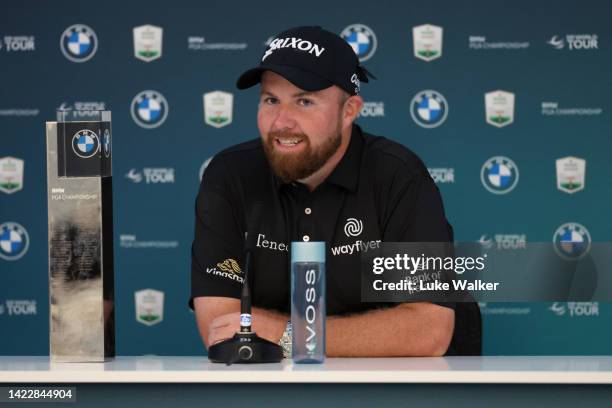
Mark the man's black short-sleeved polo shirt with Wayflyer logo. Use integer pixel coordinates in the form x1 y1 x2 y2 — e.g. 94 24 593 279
189 125 455 315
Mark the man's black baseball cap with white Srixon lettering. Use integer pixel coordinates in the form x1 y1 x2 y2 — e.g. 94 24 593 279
236 26 376 95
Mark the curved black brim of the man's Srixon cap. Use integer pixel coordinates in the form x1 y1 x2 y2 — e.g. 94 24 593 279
236 64 333 92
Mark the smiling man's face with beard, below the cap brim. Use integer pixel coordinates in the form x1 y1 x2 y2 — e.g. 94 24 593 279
257 71 346 182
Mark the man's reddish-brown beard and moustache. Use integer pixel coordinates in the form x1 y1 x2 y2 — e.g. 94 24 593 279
263 128 342 183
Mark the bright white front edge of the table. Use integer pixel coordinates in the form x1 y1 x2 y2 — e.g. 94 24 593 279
0 370 612 384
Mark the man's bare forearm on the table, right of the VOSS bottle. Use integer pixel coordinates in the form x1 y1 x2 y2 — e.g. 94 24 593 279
326 303 455 357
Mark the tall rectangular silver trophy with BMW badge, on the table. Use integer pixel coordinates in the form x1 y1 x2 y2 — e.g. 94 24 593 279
47 110 115 362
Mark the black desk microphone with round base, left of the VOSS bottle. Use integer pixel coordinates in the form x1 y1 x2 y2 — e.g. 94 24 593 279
208 201 283 365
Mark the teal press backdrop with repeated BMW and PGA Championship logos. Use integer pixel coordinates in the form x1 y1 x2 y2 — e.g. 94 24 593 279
0 0 612 355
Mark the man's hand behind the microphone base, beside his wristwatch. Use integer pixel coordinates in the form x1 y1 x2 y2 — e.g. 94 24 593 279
208 308 288 346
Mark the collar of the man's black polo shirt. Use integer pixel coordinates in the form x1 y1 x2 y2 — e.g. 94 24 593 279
272 124 363 192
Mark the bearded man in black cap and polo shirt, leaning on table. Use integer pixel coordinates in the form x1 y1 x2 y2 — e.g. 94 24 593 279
190 27 478 357
